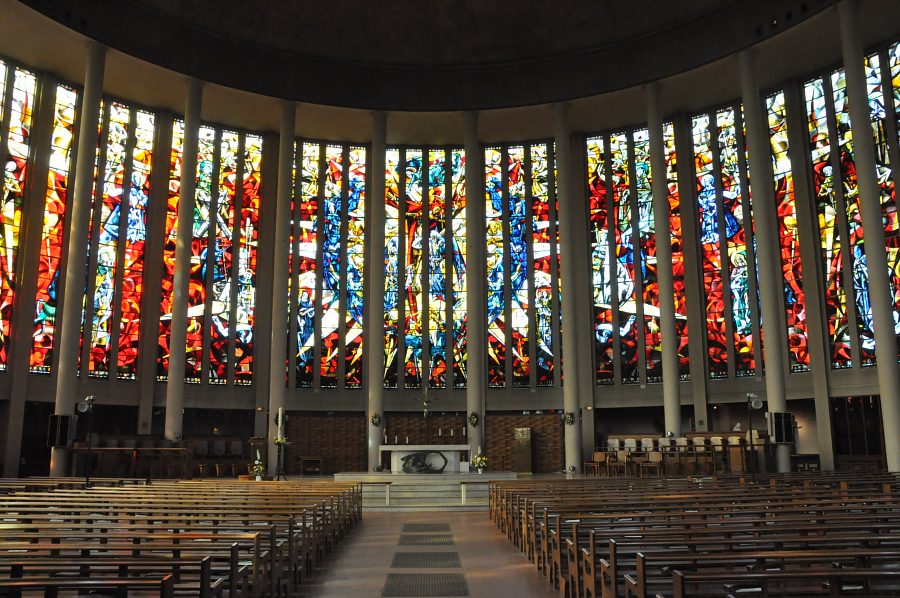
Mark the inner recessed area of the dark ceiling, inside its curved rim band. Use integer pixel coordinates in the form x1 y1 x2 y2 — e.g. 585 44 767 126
134 0 734 66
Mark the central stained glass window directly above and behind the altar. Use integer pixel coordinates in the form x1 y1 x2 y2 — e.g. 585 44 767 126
384 148 467 388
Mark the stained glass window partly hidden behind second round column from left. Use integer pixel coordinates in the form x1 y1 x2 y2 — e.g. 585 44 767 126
157 120 263 385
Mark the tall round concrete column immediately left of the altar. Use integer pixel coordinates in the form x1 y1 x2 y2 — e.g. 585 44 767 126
363 111 387 471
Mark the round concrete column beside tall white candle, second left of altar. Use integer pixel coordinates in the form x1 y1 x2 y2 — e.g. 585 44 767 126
267 100 297 475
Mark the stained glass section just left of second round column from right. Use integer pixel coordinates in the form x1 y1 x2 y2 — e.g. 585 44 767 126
692 107 759 378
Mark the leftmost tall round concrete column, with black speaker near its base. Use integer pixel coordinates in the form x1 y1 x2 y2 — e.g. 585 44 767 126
50 41 106 477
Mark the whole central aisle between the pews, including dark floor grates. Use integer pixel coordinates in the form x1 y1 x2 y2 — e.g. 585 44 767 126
300 511 559 598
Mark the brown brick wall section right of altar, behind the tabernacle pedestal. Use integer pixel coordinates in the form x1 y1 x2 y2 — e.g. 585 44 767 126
484 412 565 473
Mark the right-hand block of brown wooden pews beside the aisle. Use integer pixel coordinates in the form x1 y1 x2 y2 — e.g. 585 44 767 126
489 472 900 598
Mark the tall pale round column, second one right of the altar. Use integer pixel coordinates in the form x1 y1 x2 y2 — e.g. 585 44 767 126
553 102 587 473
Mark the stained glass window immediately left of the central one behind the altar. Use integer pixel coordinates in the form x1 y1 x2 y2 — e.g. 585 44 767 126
290 140 367 388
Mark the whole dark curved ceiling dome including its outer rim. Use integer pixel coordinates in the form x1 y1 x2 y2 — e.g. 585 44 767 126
20 0 836 111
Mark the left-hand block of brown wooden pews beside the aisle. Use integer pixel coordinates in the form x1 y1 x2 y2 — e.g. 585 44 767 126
0 478 362 598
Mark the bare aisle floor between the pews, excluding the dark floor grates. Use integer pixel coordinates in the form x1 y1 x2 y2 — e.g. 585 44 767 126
300 512 559 598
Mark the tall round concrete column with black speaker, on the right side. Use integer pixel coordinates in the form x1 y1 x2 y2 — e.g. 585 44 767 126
738 49 791 473
